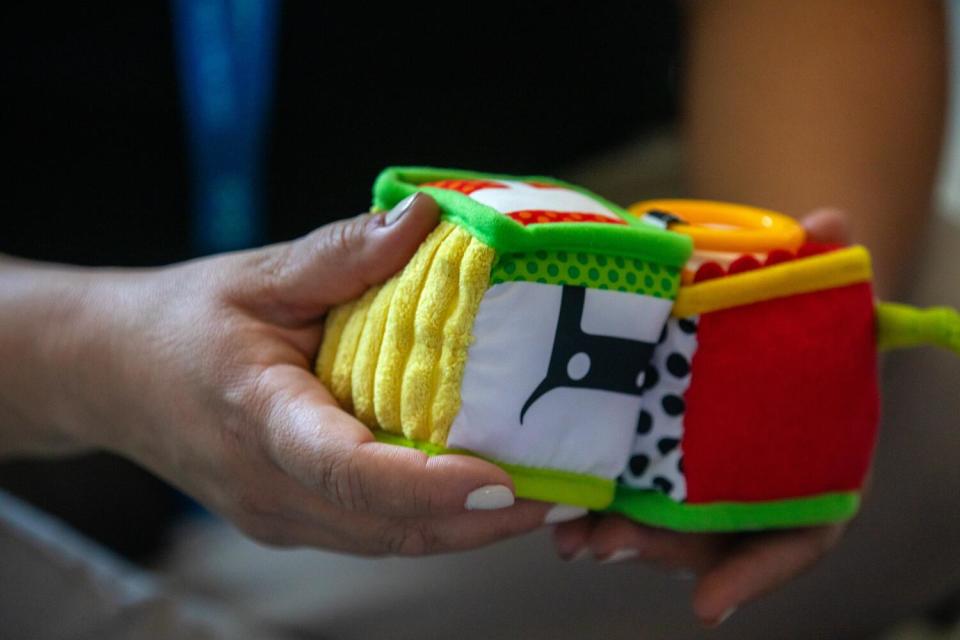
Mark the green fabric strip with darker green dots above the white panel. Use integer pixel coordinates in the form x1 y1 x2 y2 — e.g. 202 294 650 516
490 251 680 300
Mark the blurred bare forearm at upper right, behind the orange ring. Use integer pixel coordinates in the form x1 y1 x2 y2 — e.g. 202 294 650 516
685 0 946 294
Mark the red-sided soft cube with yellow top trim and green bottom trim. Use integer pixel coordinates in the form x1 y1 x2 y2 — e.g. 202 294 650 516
615 248 879 530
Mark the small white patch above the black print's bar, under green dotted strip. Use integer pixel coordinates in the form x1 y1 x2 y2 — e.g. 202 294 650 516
580 289 673 342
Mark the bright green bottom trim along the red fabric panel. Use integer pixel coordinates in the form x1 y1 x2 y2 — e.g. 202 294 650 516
608 485 860 532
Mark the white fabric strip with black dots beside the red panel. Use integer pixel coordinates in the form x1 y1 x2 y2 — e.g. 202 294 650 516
620 317 698 502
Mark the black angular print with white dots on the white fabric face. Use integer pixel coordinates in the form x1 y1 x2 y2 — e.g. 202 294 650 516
520 285 654 424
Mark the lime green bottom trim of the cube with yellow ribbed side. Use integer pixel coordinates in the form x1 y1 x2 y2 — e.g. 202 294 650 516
373 429 616 510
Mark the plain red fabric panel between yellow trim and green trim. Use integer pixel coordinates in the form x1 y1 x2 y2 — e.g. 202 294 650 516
682 283 879 503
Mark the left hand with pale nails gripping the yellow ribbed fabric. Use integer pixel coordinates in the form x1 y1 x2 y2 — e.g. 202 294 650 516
24 196 551 555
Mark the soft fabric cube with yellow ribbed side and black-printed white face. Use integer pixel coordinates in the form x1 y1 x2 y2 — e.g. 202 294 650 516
317 169 691 508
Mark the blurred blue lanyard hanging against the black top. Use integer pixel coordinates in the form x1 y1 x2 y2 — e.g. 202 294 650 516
173 0 278 255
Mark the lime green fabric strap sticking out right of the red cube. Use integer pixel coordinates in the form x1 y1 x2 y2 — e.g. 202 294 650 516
877 302 960 355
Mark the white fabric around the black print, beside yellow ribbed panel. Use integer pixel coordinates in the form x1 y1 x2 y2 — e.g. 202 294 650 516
447 282 662 479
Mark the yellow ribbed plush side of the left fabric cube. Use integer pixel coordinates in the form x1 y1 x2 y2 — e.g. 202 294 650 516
317 222 495 445
